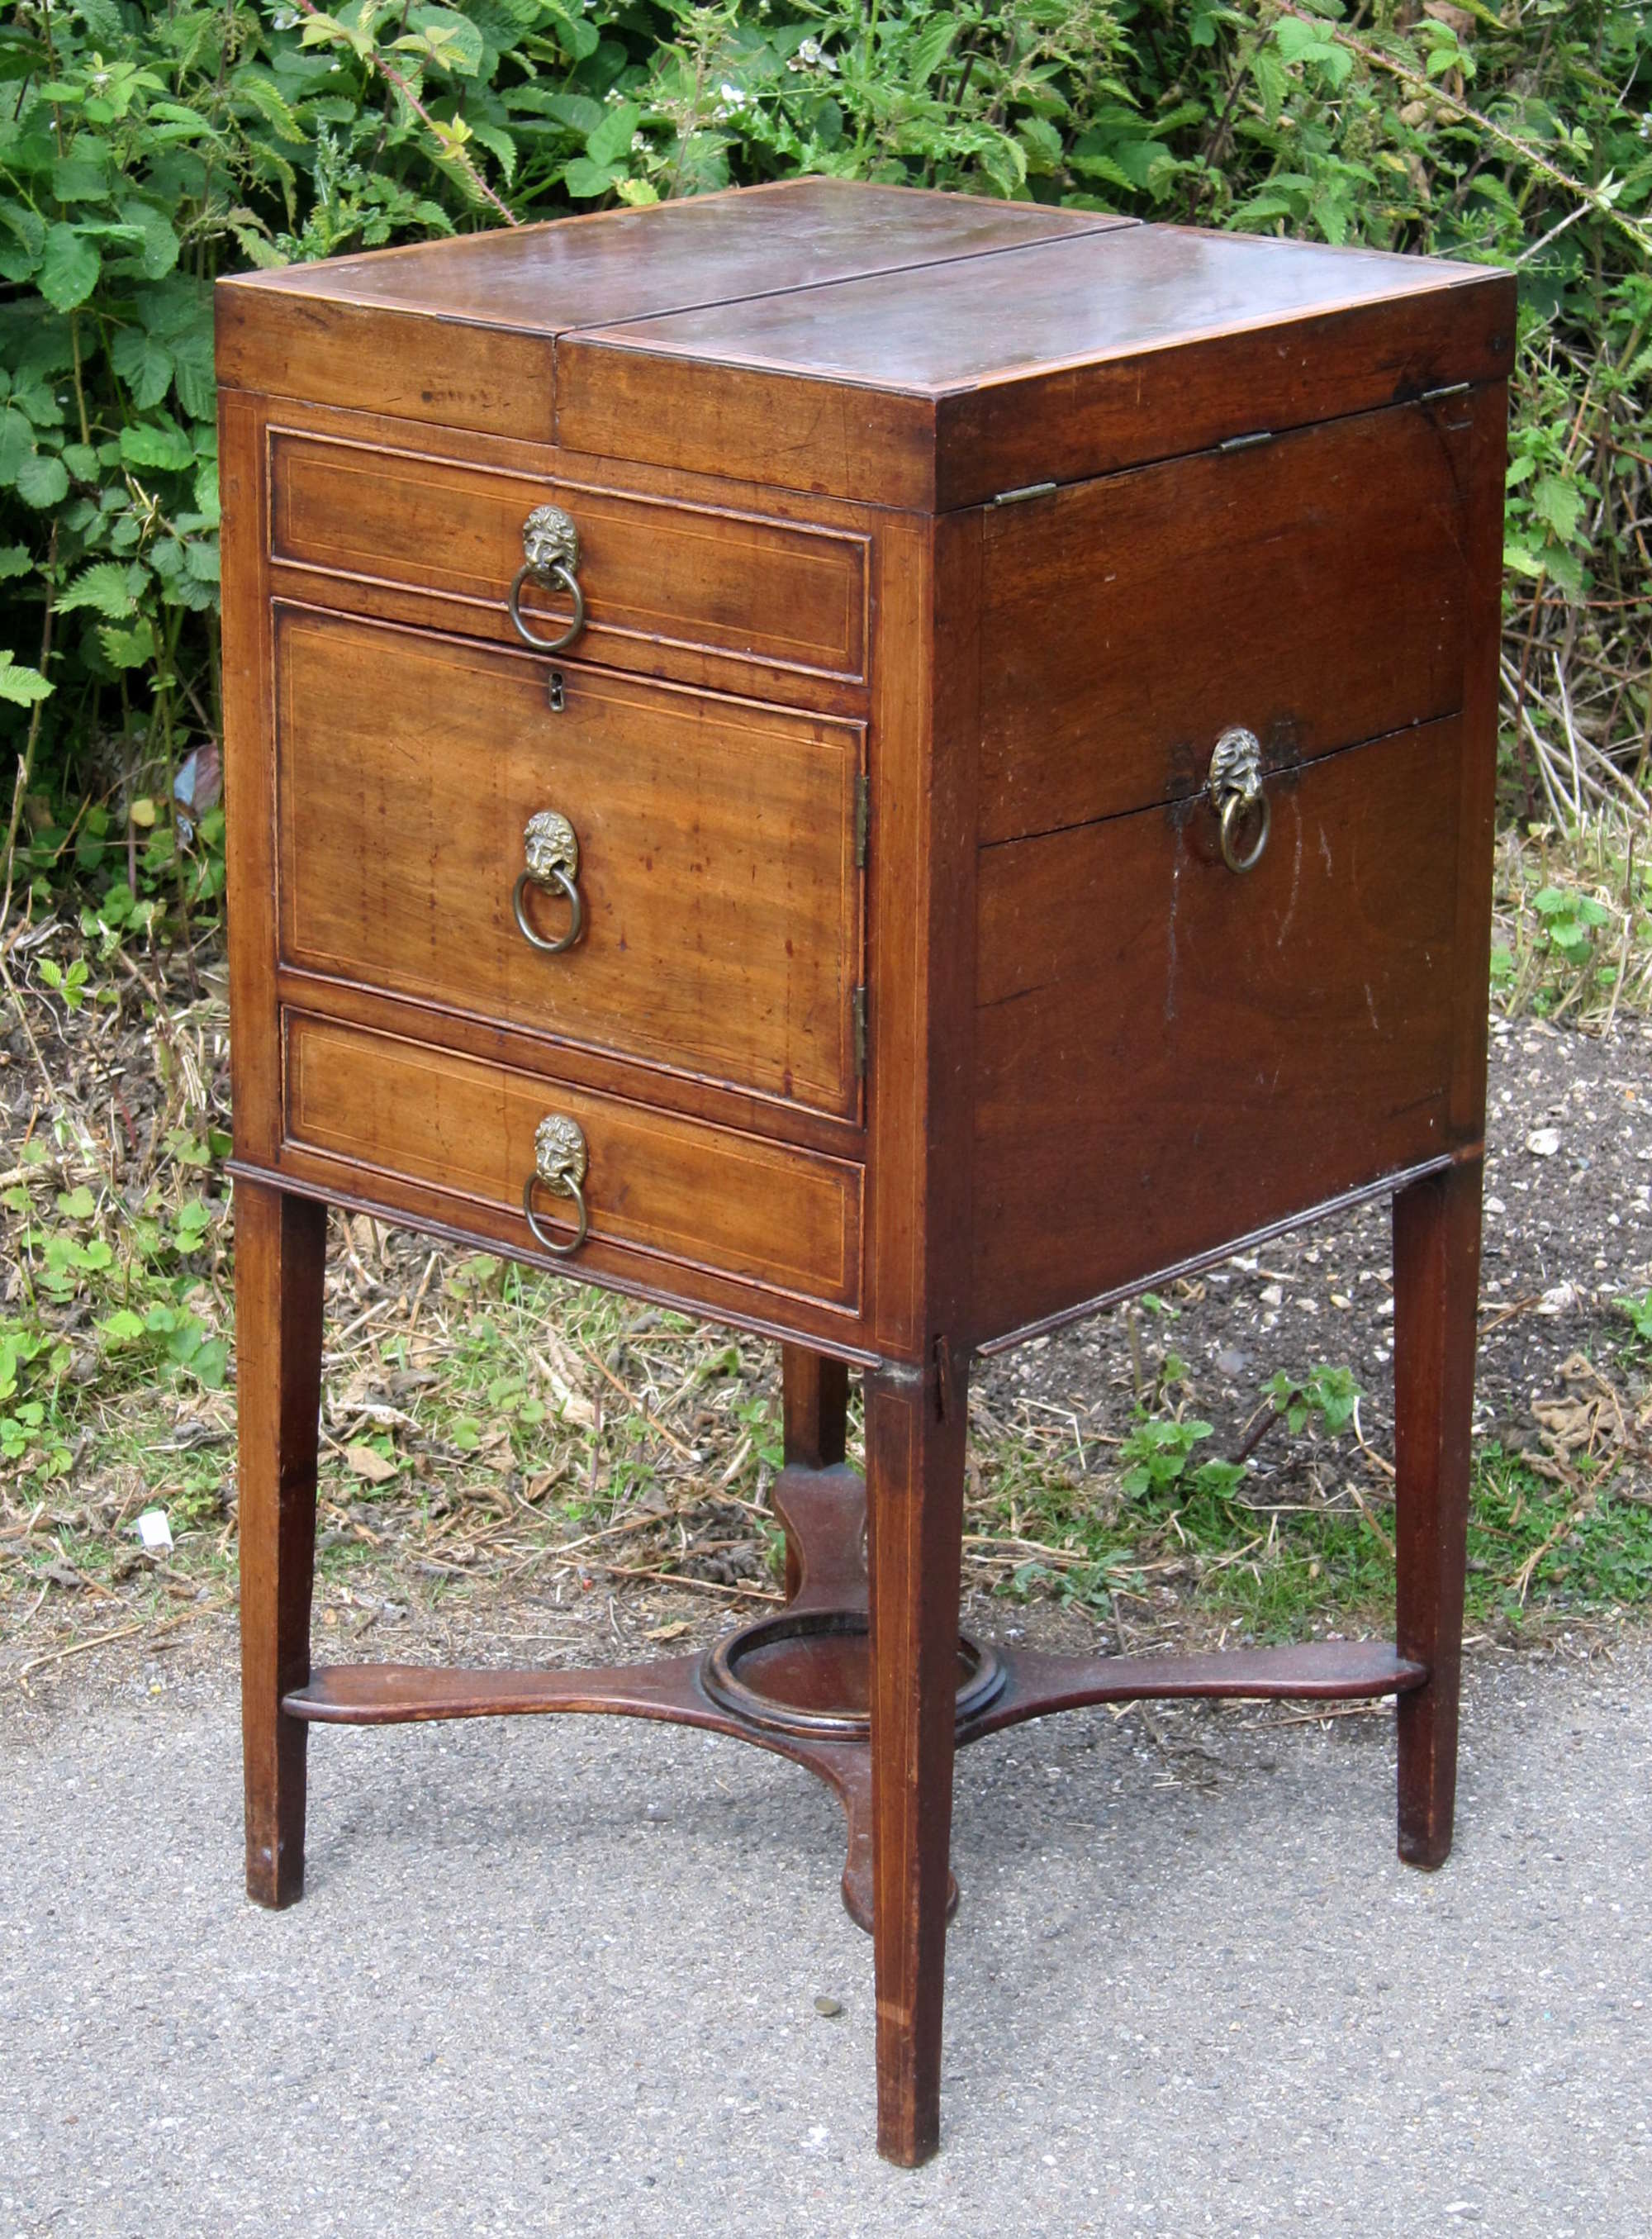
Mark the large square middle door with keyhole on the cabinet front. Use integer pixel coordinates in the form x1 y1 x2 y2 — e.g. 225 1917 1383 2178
275 609 864 1120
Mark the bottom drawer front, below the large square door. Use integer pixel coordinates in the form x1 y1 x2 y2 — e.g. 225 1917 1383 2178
282 1010 862 1312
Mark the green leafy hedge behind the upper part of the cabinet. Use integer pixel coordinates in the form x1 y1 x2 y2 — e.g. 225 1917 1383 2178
0 0 1652 940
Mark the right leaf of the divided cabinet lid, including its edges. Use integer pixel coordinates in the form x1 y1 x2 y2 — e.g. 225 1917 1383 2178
558 226 1513 513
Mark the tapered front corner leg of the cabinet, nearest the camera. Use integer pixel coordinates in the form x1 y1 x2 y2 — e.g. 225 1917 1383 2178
866 1371 967 2167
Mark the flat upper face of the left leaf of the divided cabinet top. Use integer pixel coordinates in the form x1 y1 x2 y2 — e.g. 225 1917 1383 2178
226 179 1132 338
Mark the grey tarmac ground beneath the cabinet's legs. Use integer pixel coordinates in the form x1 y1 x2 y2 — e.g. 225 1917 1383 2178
0 1634 1652 2239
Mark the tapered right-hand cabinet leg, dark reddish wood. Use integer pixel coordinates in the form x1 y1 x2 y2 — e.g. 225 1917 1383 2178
1394 1160 1479 1867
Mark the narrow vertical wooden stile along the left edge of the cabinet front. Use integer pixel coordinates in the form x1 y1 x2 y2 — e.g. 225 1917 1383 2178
217 390 282 1167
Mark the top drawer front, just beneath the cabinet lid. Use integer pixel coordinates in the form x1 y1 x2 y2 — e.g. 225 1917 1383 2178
268 430 866 683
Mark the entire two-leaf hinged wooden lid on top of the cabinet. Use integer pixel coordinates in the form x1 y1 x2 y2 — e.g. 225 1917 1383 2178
220 179 1513 511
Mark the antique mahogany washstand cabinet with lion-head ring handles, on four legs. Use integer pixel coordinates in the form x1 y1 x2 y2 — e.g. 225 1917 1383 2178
217 179 1513 2163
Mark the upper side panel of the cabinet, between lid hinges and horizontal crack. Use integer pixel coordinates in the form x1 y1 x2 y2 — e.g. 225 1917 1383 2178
980 397 1469 839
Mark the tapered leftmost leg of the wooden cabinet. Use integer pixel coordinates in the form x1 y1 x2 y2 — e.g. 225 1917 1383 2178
235 1180 327 1905
